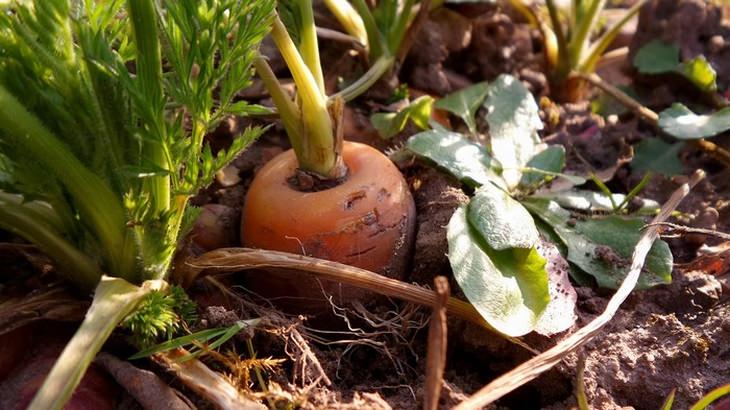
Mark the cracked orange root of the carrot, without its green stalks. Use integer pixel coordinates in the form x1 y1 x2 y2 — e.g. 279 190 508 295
241 142 415 310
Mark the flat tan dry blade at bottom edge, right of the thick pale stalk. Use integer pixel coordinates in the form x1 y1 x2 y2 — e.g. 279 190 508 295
152 349 266 410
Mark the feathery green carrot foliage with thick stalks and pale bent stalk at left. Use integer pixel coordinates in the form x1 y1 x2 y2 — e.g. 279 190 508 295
0 0 273 409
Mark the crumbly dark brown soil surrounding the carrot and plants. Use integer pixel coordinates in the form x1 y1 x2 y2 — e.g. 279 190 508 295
0 0 730 410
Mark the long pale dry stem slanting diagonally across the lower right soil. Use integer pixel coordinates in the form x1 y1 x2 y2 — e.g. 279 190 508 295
454 170 705 410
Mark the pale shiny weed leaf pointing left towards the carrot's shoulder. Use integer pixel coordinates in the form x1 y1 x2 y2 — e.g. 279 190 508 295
406 130 504 187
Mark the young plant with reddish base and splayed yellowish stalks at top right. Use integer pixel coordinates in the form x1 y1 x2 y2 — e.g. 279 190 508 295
512 0 646 102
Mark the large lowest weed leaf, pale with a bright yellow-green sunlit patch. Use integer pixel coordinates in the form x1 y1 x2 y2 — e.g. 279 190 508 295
447 206 550 336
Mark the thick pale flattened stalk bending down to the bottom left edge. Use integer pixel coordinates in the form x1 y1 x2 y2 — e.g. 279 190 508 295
28 276 166 410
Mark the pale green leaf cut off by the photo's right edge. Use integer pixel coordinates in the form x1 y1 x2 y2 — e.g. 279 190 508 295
659 103 730 140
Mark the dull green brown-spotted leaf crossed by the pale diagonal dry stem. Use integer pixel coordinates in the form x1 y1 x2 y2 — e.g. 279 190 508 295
522 198 673 289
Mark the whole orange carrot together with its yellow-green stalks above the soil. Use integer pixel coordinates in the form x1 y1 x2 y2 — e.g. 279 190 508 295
241 0 415 312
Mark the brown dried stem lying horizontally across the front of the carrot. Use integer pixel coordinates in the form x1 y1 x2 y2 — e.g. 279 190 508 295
184 248 539 354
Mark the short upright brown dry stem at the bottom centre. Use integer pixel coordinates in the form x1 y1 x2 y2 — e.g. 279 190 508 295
423 276 450 410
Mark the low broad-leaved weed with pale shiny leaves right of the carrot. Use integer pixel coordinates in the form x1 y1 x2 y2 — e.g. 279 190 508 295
401 75 672 336
